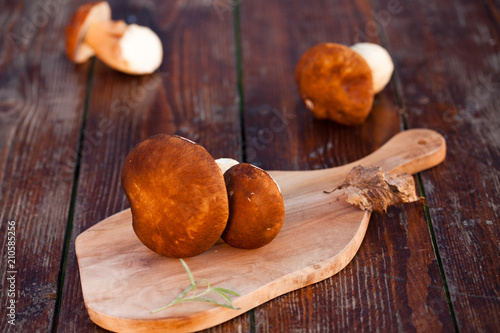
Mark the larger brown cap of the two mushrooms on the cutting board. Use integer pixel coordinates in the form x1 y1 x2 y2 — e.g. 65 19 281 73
122 134 229 258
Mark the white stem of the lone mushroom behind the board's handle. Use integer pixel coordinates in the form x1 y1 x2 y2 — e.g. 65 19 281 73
351 43 394 94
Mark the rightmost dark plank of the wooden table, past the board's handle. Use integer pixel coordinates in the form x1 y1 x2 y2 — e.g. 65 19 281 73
379 1 500 332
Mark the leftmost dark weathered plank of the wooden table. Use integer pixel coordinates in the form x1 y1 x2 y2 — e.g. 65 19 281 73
0 1 87 332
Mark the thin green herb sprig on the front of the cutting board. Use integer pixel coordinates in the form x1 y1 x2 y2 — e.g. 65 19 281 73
151 259 240 313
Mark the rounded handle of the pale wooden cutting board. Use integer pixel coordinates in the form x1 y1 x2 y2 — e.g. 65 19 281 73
355 128 446 174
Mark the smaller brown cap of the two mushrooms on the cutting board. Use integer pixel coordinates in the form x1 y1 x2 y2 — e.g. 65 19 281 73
222 163 285 249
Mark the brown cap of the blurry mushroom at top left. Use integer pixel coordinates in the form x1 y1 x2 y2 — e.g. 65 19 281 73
66 1 111 64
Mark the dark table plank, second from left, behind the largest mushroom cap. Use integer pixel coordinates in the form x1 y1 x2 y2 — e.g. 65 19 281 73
57 0 245 332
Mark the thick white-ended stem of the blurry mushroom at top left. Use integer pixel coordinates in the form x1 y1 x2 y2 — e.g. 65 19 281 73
83 21 163 75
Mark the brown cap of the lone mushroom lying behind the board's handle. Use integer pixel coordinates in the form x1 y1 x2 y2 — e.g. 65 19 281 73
295 43 374 125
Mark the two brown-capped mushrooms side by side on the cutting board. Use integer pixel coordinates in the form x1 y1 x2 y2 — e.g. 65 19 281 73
121 134 285 258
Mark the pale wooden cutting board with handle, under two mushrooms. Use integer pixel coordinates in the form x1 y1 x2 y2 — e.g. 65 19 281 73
76 129 446 332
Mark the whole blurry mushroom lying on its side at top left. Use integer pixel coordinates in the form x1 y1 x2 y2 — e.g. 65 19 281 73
66 1 163 75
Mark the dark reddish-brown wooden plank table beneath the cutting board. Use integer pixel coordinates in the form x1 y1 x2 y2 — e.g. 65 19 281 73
0 0 500 332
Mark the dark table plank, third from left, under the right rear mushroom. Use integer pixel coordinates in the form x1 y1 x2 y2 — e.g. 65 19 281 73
241 0 453 332
